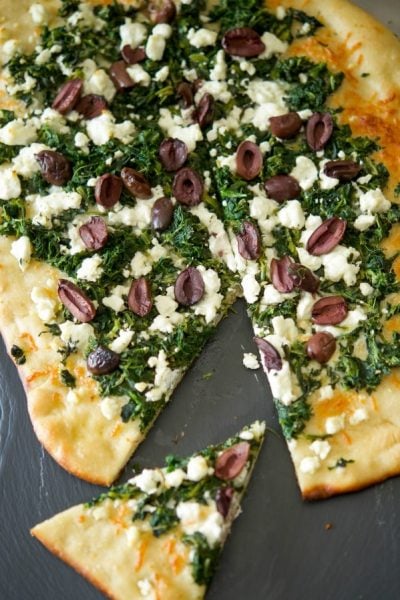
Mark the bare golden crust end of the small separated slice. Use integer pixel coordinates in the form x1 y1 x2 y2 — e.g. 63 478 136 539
31 501 205 600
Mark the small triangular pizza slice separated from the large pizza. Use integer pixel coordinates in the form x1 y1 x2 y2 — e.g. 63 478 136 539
32 421 265 600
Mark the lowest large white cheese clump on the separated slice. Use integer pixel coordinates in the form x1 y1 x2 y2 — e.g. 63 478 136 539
176 502 224 547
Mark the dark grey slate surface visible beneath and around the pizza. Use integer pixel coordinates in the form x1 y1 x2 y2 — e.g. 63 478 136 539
0 0 400 600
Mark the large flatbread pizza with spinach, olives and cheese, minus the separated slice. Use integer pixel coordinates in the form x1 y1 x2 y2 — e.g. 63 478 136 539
0 0 400 499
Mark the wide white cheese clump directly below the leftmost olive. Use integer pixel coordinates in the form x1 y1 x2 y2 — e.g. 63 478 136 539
26 188 82 227
